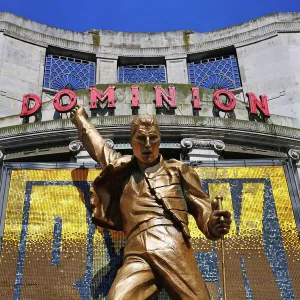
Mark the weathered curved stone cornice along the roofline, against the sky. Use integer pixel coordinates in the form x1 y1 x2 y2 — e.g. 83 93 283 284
0 13 300 56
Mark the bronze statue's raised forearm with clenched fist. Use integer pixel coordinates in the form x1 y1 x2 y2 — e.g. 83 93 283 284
71 104 121 168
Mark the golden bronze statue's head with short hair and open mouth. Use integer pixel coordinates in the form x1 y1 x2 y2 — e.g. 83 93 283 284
130 115 160 168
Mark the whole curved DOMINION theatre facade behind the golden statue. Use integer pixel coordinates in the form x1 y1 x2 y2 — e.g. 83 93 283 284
0 13 300 300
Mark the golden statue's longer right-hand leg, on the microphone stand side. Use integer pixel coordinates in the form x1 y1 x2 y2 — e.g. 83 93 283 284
145 226 210 300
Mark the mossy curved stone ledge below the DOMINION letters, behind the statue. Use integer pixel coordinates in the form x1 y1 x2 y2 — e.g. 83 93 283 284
0 115 300 149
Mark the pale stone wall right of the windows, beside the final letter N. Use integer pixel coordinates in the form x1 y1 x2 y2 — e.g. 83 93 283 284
237 33 300 127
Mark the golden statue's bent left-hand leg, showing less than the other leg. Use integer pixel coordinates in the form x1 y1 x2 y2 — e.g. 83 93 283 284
108 256 158 300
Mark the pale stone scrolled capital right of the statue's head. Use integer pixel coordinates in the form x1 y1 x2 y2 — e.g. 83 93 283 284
181 138 225 161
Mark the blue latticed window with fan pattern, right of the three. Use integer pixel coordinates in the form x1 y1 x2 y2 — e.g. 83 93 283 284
188 55 241 90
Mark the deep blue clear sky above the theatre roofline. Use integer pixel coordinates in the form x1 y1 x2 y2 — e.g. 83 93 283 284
0 0 300 32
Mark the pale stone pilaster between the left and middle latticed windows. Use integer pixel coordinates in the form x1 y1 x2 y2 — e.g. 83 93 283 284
96 54 118 84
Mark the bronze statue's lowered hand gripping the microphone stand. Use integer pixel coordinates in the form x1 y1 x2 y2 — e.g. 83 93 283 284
208 199 232 237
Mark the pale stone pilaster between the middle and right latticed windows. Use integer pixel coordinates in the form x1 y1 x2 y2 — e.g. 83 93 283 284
165 54 189 83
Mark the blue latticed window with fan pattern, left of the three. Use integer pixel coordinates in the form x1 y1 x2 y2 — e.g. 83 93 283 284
44 55 95 91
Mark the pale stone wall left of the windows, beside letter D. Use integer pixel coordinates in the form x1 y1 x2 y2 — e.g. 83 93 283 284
0 33 46 119
